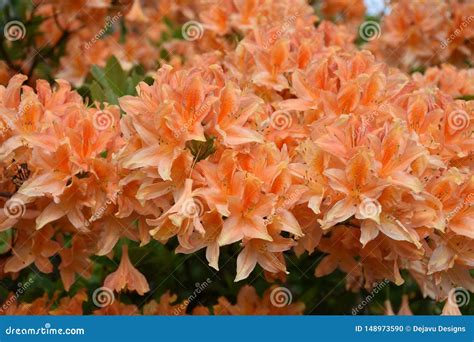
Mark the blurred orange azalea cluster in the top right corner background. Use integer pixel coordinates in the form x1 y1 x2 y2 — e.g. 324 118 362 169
367 0 474 71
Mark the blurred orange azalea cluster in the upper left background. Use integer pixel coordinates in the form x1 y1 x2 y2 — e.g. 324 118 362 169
0 0 174 87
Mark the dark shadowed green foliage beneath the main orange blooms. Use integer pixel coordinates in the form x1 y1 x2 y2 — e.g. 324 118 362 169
0 239 474 315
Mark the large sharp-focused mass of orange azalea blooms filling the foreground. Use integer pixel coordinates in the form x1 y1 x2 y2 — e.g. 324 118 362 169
0 0 474 314
